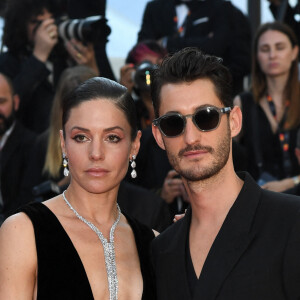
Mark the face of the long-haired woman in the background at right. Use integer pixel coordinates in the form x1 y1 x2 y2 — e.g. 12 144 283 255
257 30 298 76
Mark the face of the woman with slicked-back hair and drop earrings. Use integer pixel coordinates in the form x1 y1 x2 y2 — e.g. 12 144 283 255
61 99 140 193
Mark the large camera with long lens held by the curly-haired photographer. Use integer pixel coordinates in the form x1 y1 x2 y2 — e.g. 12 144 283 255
55 16 111 43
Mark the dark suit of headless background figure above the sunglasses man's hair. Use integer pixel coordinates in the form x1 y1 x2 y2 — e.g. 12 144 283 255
138 0 251 94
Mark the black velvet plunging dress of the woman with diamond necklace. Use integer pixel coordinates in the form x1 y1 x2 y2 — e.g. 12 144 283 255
19 202 156 300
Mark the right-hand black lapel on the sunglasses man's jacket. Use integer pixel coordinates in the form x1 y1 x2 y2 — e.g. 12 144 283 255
193 175 261 300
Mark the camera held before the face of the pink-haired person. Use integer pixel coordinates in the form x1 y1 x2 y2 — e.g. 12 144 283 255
132 60 158 91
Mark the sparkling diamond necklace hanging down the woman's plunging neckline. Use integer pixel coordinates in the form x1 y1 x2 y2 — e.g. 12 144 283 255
62 191 121 300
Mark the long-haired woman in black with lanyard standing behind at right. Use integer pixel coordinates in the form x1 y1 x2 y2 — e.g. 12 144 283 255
235 22 300 192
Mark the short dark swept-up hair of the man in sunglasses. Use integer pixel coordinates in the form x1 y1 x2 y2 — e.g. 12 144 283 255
151 48 233 118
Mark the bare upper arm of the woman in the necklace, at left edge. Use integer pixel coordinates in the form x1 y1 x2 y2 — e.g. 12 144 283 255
0 213 37 300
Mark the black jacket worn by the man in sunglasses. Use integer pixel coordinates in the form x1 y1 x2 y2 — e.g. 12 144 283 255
152 174 300 300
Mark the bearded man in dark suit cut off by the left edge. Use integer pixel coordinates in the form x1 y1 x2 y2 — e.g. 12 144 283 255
0 74 35 223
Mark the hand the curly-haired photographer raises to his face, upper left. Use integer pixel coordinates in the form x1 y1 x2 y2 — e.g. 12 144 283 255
33 19 58 62
